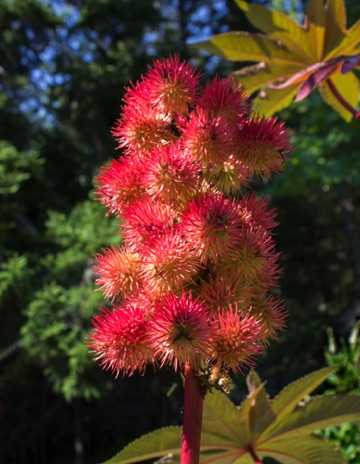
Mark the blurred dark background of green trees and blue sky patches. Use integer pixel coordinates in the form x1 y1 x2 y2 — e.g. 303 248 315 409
0 0 360 464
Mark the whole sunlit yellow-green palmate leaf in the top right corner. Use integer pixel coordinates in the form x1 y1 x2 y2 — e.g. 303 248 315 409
197 0 360 121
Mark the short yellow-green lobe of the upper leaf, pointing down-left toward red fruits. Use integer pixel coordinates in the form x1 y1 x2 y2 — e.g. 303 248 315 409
253 84 301 117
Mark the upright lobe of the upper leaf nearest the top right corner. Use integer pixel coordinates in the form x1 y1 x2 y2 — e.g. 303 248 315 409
324 0 346 56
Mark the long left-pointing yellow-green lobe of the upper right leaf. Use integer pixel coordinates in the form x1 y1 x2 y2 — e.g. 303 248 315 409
195 32 303 67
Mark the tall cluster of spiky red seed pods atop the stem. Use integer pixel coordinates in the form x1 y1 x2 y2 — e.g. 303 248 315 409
88 57 290 375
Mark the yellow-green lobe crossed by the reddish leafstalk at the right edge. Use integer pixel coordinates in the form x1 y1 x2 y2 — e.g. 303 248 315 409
319 72 360 122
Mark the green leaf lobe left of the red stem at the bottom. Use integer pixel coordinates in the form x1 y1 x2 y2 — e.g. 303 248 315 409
104 427 181 464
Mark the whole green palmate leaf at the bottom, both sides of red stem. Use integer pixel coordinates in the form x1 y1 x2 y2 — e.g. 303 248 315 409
106 368 360 464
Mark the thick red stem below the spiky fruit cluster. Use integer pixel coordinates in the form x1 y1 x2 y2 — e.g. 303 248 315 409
180 363 204 464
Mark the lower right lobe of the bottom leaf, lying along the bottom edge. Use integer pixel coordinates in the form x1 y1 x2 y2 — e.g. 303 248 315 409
257 436 344 464
